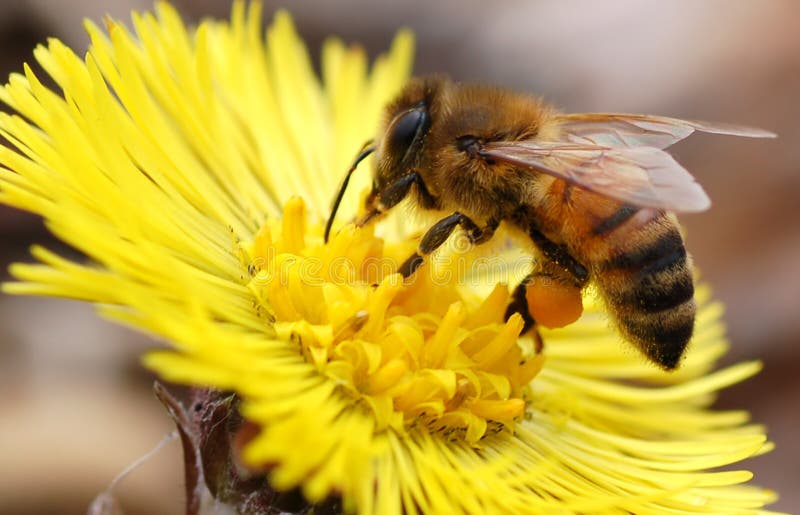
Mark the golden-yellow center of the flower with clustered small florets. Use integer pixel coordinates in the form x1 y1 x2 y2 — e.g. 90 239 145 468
234 198 542 444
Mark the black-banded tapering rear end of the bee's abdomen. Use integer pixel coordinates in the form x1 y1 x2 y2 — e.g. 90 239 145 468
596 223 696 370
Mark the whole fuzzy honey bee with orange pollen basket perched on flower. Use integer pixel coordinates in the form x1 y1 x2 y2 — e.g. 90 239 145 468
325 76 775 370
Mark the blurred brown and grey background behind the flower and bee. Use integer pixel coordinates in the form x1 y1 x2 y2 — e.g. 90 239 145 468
0 0 800 515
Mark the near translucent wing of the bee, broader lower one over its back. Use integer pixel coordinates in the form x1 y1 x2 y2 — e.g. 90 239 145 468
480 141 711 212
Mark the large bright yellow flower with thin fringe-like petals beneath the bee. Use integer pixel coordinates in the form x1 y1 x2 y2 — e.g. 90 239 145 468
0 2 774 514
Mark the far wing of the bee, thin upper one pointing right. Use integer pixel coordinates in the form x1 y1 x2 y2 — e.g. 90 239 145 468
556 113 775 148
